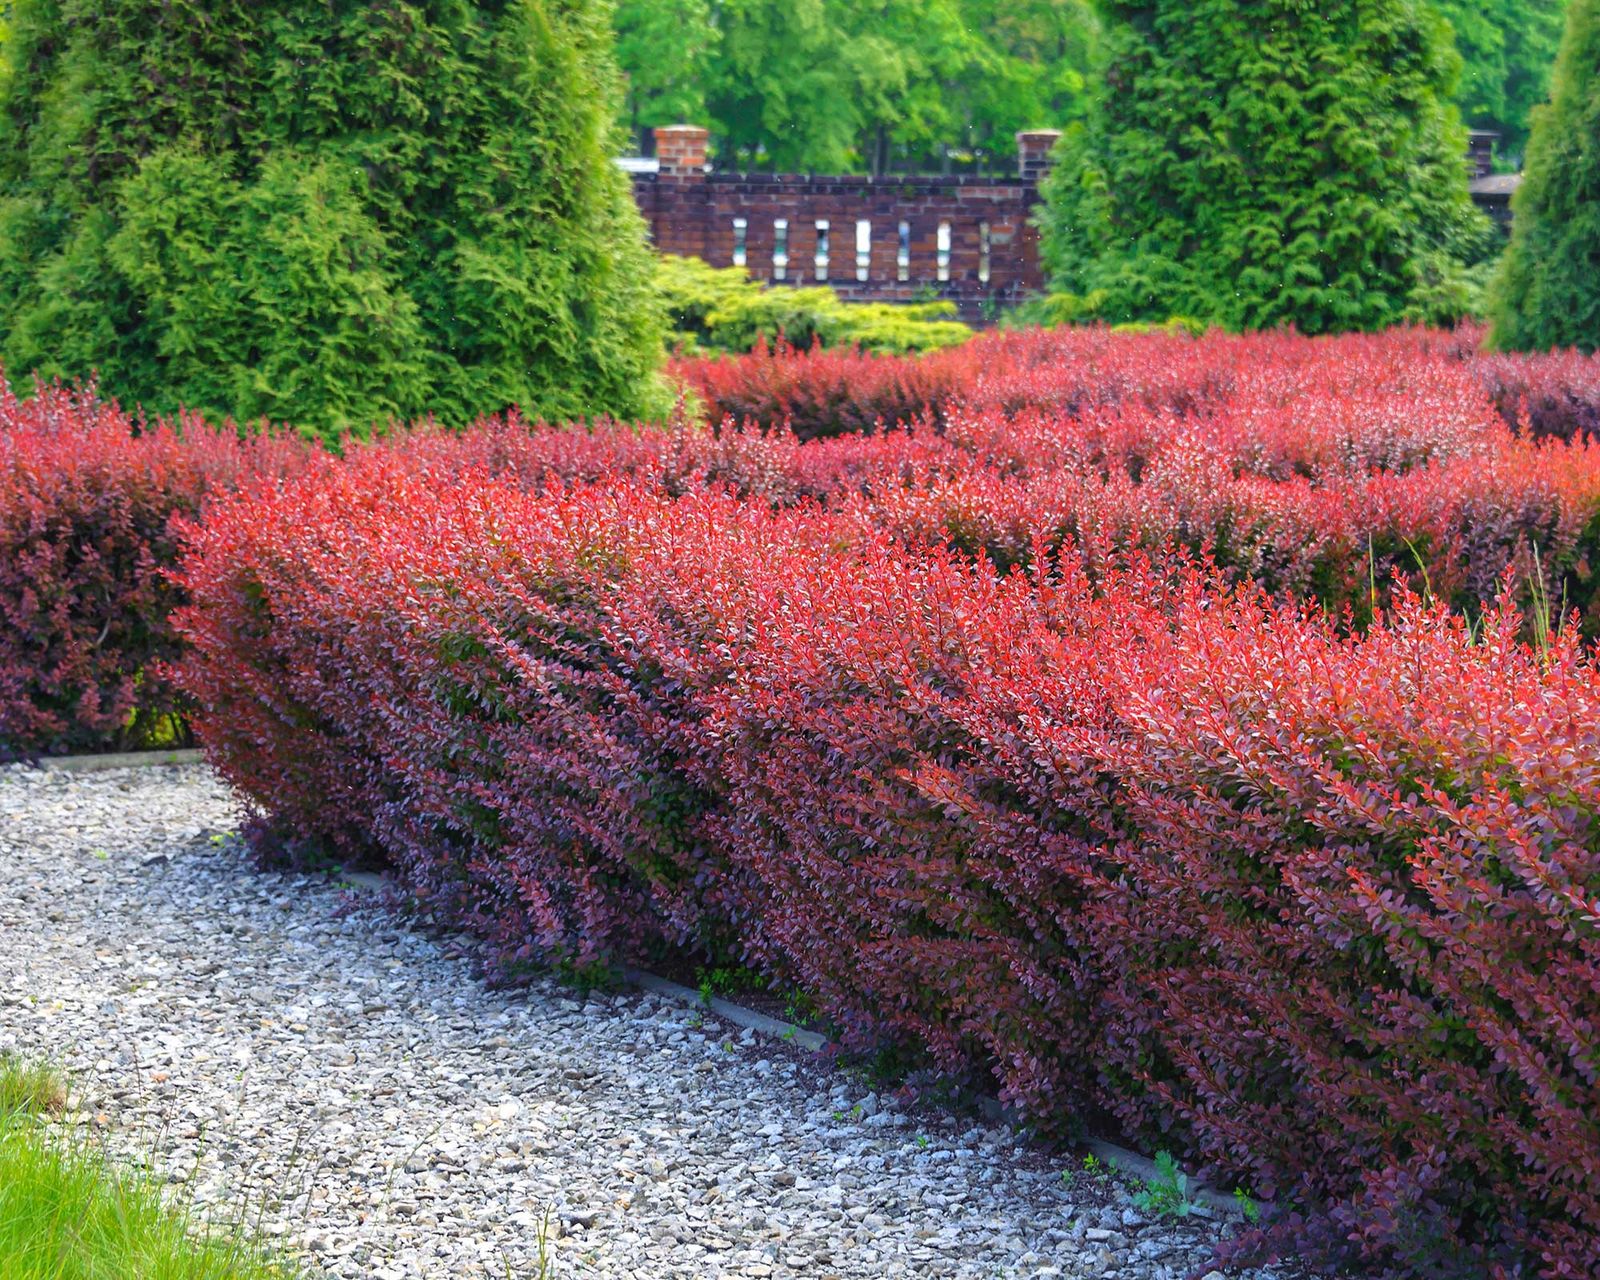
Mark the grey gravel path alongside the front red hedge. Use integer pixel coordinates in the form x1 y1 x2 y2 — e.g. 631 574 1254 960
0 768 1270 1280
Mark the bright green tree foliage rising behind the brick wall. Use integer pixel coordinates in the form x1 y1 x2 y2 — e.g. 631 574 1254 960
616 0 1094 173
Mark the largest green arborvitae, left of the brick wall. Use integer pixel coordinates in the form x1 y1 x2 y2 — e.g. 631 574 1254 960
0 0 661 432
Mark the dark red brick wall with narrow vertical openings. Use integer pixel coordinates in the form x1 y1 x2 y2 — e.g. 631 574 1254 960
634 125 1058 320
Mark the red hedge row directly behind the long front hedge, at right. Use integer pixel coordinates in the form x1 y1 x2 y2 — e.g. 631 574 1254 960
835 428 1600 637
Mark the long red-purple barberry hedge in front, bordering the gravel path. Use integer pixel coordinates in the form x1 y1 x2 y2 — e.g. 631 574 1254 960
168 450 1600 1280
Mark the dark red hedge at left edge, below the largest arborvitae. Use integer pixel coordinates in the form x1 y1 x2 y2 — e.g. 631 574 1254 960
0 379 304 758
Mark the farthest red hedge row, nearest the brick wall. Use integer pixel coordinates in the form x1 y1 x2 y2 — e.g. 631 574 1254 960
672 326 1600 440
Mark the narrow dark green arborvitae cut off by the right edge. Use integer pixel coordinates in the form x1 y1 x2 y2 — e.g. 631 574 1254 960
1491 0 1600 352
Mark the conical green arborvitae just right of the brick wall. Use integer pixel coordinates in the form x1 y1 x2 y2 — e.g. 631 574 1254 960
1042 0 1486 333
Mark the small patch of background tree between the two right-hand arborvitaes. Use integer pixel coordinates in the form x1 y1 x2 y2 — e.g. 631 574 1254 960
1434 0 1566 168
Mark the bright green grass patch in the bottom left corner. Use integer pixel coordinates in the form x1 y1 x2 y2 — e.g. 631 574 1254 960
0 1054 299 1280
